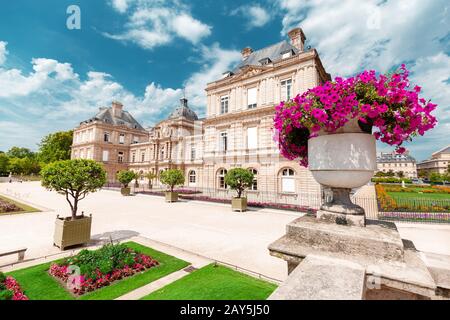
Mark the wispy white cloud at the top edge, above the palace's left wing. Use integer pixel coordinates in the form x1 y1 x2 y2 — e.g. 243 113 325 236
103 0 211 49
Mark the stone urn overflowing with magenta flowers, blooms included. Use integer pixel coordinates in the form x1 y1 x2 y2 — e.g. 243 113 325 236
274 65 437 226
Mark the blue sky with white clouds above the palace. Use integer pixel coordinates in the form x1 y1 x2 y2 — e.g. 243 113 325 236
0 0 450 159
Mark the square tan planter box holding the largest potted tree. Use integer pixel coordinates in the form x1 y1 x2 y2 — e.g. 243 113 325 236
53 216 92 250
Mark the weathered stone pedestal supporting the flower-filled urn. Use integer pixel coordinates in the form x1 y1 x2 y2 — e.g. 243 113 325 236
269 216 445 299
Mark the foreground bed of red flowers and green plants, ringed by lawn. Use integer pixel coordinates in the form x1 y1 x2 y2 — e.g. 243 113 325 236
49 244 159 296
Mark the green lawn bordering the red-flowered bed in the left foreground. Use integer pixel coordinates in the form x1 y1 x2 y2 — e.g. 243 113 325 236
9 242 189 300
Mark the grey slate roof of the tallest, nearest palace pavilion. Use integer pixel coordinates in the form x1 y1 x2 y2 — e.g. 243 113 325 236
232 40 299 73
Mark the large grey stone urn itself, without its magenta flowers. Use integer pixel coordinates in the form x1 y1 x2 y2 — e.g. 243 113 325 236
308 119 377 226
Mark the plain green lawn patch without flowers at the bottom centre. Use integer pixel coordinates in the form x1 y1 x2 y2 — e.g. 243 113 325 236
142 264 277 300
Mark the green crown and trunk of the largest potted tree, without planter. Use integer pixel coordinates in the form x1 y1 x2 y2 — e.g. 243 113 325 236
41 159 106 220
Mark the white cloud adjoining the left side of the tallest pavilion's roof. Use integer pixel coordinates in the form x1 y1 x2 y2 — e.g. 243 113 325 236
185 43 242 112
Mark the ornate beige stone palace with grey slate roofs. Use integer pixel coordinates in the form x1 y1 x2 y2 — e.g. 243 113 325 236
72 28 330 203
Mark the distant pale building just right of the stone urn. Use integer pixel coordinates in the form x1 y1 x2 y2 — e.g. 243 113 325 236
377 152 417 178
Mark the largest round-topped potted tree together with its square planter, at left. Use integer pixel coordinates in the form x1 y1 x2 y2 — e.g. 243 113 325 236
41 159 106 250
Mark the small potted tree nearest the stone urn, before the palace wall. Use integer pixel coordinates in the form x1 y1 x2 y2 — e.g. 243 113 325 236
225 168 254 212
